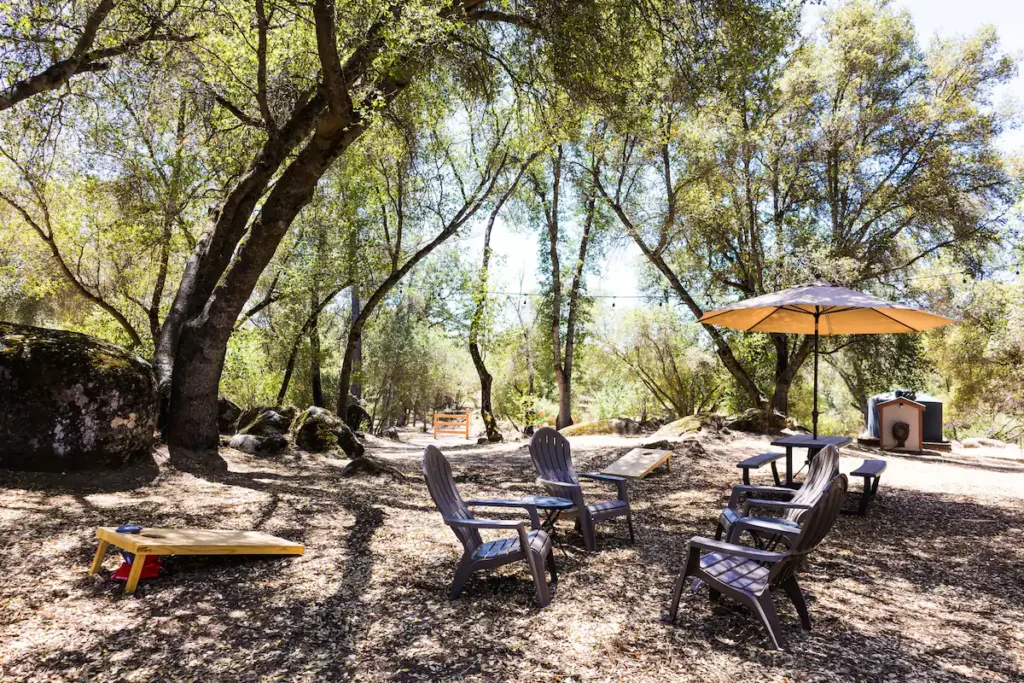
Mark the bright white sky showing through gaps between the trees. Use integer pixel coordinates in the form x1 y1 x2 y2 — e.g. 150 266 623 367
460 0 1024 309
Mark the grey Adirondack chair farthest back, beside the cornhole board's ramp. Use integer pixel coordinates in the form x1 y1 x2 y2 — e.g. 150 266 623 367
529 427 634 553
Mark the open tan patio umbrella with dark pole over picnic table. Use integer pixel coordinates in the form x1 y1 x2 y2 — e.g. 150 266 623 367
697 280 956 438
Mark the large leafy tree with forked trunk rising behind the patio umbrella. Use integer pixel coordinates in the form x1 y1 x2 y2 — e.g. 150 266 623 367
600 0 1019 413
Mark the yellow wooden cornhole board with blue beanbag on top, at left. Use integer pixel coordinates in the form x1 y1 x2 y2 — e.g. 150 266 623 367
89 526 305 593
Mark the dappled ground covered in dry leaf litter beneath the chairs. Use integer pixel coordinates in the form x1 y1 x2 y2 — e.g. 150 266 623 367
0 433 1024 682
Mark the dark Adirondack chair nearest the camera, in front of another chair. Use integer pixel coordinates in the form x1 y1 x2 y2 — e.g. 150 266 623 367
669 474 847 649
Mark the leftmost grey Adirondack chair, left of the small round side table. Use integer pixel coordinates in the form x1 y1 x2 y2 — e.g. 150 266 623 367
423 445 558 607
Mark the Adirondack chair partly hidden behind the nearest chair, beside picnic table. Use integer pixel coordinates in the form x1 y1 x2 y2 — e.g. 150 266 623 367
715 445 839 549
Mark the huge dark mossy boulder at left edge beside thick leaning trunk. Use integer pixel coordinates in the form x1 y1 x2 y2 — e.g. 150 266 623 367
0 323 157 471
